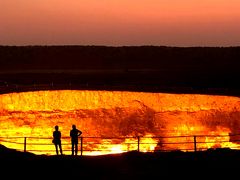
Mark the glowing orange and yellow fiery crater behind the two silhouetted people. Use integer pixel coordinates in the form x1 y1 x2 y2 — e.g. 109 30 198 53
0 90 240 155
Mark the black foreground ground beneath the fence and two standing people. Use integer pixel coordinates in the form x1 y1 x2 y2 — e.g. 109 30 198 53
0 147 240 179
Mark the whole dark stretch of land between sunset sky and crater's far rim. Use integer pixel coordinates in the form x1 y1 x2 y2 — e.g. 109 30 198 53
0 46 240 94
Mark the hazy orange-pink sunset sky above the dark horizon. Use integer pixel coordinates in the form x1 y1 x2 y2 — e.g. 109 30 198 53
0 0 240 46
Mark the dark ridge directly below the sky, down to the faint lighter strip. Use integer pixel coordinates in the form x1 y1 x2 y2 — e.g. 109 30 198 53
0 46 240 72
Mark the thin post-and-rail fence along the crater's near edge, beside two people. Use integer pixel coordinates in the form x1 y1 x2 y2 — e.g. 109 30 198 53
0 134 240 155
